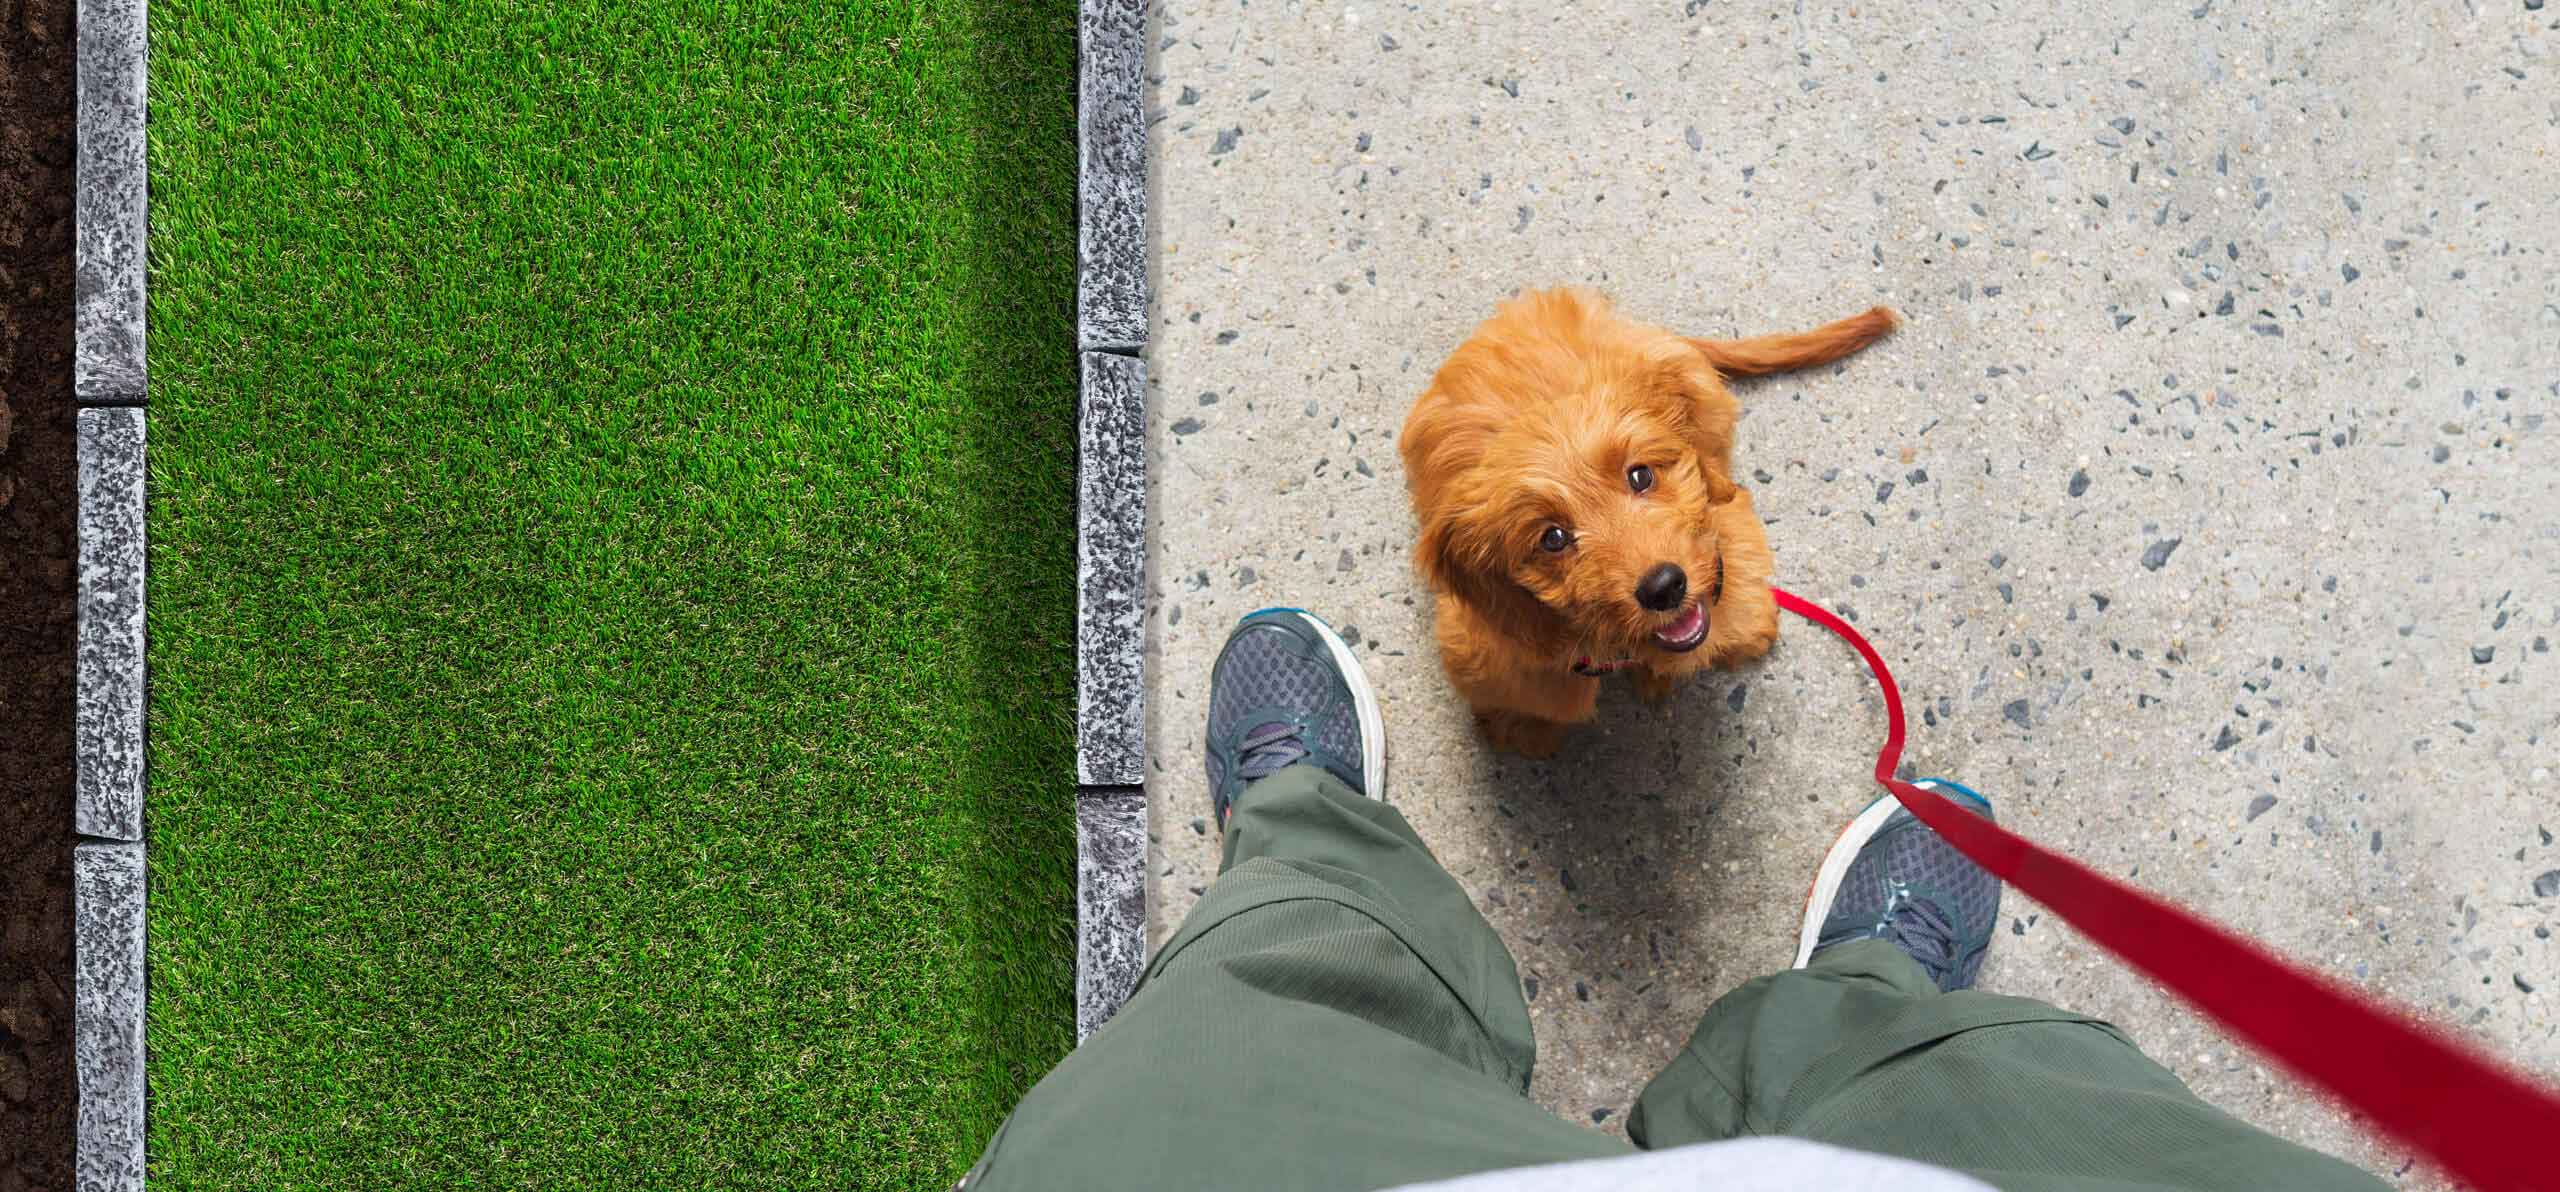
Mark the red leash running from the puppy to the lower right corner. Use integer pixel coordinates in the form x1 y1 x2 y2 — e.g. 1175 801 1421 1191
1777 591 2560 1192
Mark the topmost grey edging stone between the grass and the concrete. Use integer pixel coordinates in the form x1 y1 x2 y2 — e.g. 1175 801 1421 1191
1080 0 1147 353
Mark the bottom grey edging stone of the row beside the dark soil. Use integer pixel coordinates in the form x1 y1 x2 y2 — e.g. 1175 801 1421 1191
72 842 143 1192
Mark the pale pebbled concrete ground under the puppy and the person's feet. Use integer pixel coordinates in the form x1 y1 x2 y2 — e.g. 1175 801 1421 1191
1147 0 2560 1187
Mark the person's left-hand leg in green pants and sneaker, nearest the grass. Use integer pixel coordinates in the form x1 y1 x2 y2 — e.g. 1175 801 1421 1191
968 611 1626 1192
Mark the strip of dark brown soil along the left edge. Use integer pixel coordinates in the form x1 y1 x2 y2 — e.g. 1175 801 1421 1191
0 0 77 1176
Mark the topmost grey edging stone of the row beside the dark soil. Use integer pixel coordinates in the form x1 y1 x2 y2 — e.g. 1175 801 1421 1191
72 0 148 402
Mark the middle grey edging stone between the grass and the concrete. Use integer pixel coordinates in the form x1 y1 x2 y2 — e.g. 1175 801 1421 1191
1075 353 1147 785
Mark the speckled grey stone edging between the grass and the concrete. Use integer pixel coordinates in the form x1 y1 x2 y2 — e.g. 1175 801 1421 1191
1075 0 1147 1041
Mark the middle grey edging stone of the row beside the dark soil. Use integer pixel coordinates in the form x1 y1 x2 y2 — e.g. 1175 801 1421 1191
72 407 143 839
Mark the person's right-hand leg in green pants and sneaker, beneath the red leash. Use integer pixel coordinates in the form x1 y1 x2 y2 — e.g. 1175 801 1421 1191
1628 783 2386 1192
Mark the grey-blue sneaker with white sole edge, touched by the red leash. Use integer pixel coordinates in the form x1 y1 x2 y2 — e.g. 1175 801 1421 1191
1795 778 1999 992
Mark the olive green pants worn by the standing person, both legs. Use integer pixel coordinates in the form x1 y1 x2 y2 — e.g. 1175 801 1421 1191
968 765 2383 1192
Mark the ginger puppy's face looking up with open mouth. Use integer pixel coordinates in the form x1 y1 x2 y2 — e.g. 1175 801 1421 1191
1418 358 1748 670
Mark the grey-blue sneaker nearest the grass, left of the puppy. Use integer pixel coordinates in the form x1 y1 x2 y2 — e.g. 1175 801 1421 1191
1208 609 1388 826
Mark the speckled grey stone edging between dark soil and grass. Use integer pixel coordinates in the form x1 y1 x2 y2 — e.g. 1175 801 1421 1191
72 0 148 1192
